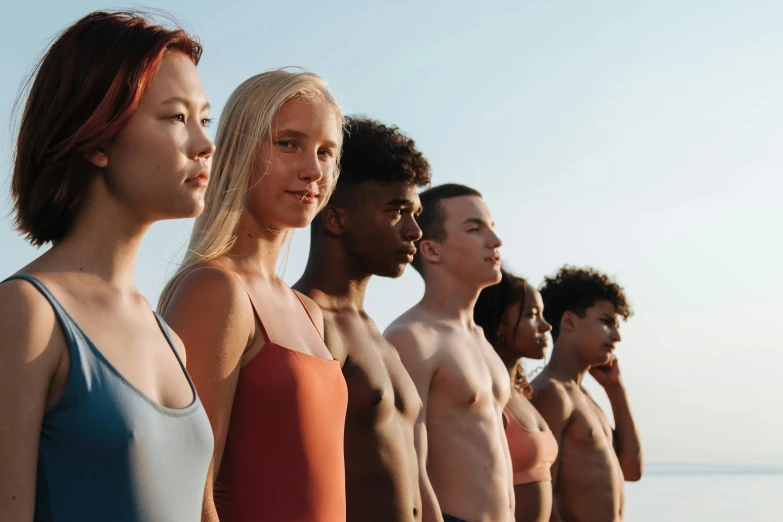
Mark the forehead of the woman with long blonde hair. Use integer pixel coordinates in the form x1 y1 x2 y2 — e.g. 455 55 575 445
273 98 342 143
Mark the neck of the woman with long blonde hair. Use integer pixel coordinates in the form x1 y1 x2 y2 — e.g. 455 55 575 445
226 211 292 278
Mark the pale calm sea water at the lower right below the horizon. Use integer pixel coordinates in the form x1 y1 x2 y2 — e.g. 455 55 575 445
625 464 783 522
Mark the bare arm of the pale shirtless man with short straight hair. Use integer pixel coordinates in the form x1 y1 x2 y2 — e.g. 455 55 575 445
384 328 443 522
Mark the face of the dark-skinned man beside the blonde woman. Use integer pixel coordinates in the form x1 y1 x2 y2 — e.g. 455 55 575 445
341 181 421 277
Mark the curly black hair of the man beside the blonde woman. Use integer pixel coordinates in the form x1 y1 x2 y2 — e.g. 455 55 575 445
332 116 432 201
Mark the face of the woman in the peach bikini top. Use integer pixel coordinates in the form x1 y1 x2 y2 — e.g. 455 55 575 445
502 285 552 359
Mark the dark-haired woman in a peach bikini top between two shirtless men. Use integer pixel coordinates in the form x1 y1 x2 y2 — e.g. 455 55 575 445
474 270 557 522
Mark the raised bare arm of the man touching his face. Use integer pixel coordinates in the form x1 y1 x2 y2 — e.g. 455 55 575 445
590 358 643 481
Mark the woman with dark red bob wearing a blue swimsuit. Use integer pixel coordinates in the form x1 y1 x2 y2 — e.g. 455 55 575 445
0 12 214 522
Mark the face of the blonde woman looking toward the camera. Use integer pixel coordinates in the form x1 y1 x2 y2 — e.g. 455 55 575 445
247 98 342 231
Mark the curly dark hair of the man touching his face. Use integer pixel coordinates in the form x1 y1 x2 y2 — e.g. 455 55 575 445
540 265 633 340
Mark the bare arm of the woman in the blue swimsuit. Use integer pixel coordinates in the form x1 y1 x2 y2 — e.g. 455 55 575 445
0 281 67 522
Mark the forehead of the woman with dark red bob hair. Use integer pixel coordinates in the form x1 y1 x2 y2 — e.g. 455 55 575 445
144 51 206 106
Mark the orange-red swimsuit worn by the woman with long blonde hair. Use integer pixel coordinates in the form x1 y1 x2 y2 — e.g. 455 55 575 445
214 286 348 522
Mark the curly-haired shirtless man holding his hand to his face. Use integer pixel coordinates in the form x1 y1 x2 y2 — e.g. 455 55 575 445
532 266 642 522
